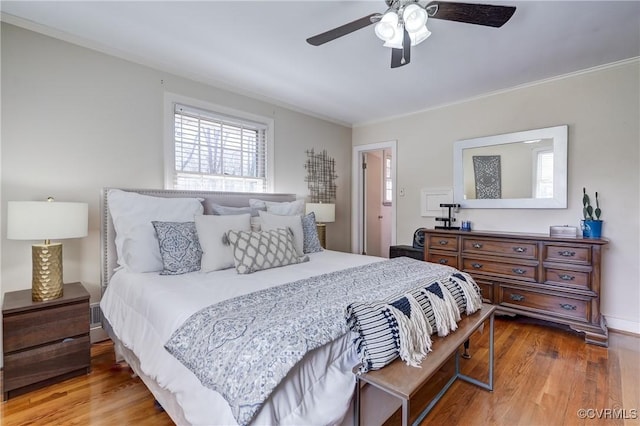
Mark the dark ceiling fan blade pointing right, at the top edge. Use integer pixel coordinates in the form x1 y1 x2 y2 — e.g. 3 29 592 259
426 1 516 28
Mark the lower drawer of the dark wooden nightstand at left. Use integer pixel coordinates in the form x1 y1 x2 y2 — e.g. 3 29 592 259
3 335 91 392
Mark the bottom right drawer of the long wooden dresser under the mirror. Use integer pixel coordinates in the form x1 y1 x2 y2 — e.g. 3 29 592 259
497 285 589 321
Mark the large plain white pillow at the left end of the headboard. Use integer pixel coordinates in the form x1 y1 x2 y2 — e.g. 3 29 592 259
107 189 204 272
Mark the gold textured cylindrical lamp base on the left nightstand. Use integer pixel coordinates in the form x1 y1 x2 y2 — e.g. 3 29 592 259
31 243 63 302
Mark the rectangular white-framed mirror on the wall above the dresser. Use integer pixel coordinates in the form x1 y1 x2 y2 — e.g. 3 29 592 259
453 125 568 209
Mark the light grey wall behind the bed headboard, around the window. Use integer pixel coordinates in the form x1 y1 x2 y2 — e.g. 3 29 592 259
0 23 351 358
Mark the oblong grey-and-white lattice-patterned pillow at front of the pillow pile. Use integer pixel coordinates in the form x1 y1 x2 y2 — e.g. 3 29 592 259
227 228 309 274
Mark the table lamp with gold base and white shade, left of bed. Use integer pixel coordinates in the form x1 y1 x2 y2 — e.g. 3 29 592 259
7 198 88 302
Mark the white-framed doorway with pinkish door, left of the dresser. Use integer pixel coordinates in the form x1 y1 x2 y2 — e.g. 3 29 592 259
351 141 397 257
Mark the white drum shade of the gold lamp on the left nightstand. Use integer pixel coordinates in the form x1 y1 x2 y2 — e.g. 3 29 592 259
7 201 89 240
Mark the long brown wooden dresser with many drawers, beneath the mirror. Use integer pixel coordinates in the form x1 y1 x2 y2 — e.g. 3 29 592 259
424 229 608 346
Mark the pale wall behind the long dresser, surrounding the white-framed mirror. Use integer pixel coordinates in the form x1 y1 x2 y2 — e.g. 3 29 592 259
353 60 640 333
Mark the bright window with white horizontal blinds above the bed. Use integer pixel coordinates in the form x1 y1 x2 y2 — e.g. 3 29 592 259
165 95 272 192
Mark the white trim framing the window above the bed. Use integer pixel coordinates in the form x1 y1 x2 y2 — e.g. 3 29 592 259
163 92 275 192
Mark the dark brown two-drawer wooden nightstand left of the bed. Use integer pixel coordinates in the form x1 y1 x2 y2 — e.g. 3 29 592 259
2 283 91 400
